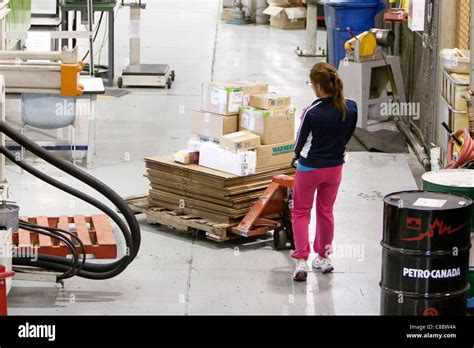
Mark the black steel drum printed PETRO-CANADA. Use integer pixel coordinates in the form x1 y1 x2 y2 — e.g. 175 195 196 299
380 191 472 315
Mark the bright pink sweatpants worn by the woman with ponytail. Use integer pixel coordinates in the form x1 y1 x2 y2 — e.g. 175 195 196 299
292 166 342 260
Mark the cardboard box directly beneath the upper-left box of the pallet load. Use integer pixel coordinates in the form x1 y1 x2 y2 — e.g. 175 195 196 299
191 110 239 140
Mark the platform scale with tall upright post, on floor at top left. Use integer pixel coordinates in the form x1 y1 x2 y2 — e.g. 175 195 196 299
117 0 176 89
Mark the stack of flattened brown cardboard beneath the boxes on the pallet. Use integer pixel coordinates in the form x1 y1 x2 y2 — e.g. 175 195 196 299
145 156 293 224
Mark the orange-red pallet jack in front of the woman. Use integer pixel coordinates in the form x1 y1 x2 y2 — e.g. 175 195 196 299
232 158 297 250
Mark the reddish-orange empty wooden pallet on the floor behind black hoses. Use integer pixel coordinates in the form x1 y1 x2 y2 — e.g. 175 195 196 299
13 215 117 259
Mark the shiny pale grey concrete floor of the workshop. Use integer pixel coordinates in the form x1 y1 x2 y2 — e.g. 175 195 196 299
7 0 416 315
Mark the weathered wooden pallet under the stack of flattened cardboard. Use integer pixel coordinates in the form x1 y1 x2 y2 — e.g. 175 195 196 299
125 195 238 242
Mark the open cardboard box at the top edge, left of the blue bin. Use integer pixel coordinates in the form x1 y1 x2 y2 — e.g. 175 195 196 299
263 0 306 29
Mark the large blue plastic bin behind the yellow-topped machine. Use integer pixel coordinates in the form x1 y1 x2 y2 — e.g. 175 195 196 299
324 0 385 68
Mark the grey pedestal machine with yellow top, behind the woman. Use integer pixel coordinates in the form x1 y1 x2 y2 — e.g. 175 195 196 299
338 29 410 129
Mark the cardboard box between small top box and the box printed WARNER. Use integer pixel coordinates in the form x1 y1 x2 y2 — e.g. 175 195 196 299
243 106 295 145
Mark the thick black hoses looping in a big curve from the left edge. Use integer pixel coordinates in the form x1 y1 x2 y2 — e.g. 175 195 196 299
0 121 141 280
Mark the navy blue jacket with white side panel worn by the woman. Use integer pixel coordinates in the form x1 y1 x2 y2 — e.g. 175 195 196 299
295 98 357 168
